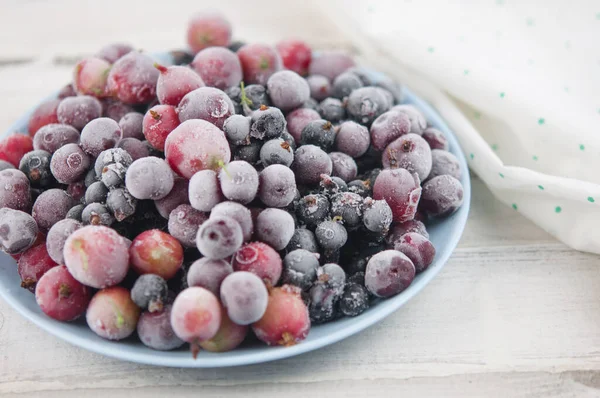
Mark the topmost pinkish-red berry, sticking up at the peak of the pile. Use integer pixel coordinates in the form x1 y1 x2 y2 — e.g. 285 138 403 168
187 13 231 53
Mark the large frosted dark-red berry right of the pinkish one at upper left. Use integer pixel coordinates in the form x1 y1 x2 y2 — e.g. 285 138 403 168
106 51 159 105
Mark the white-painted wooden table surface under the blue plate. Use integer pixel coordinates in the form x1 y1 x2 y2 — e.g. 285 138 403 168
0 0 600 398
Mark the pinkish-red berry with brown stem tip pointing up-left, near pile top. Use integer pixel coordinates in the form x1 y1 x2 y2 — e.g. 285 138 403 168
154 64 205 106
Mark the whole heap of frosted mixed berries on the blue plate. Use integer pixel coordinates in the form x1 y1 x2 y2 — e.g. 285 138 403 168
0 14 463 352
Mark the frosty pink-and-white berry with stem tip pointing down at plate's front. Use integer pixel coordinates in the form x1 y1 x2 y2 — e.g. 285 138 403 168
171 287 222 352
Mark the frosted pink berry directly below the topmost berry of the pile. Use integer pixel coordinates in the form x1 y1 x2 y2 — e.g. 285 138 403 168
191 47 242 90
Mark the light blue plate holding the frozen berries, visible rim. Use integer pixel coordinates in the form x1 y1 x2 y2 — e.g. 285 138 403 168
0 67 471 368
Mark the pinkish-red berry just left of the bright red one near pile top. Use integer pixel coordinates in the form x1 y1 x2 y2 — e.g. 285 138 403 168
237 44 282 86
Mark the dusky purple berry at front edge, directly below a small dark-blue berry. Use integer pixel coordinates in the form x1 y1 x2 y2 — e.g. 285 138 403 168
137 305 185 351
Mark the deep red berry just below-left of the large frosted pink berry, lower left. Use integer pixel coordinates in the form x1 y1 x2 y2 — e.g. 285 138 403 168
35 265 91 321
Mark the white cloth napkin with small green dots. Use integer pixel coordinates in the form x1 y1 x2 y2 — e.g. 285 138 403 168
315 0 600 253
